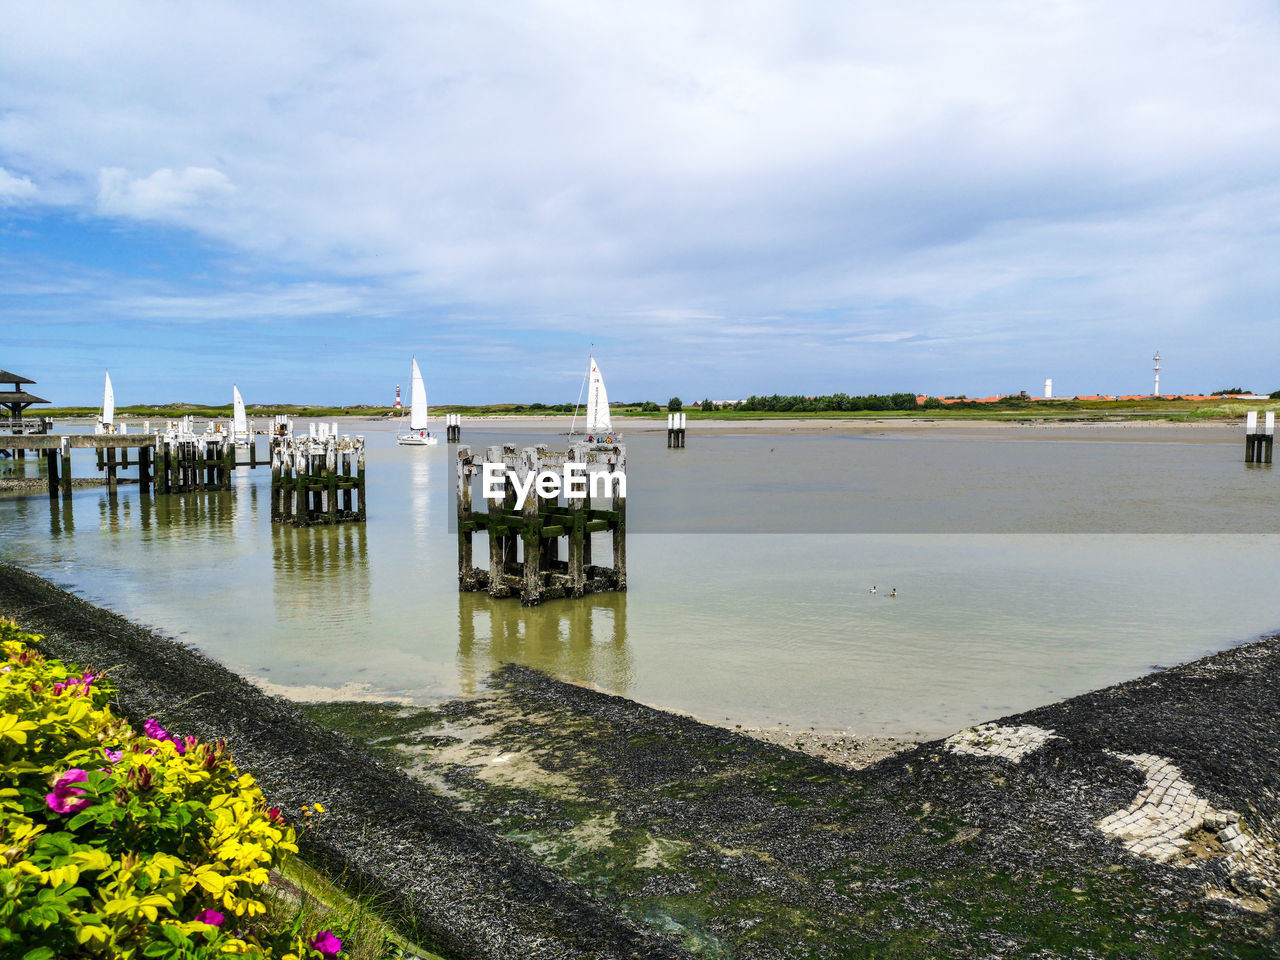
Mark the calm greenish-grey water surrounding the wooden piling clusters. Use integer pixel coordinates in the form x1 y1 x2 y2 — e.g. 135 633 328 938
0 422 1280 735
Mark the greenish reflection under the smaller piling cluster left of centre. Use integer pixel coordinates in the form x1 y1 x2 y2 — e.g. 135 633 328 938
271 524 369 630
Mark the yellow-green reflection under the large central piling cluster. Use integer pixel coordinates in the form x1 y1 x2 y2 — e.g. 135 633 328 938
458 593 634 696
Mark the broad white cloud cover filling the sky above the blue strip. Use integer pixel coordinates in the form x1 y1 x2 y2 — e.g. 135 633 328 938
0 0 1280 392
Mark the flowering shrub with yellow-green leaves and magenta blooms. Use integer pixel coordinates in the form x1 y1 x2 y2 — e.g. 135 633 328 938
0 621 342 960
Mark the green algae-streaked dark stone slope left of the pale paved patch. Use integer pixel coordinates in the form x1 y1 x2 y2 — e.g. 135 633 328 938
308 654 1280 957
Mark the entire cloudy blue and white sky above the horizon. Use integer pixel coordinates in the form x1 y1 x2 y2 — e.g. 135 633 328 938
0 0 1280 404
